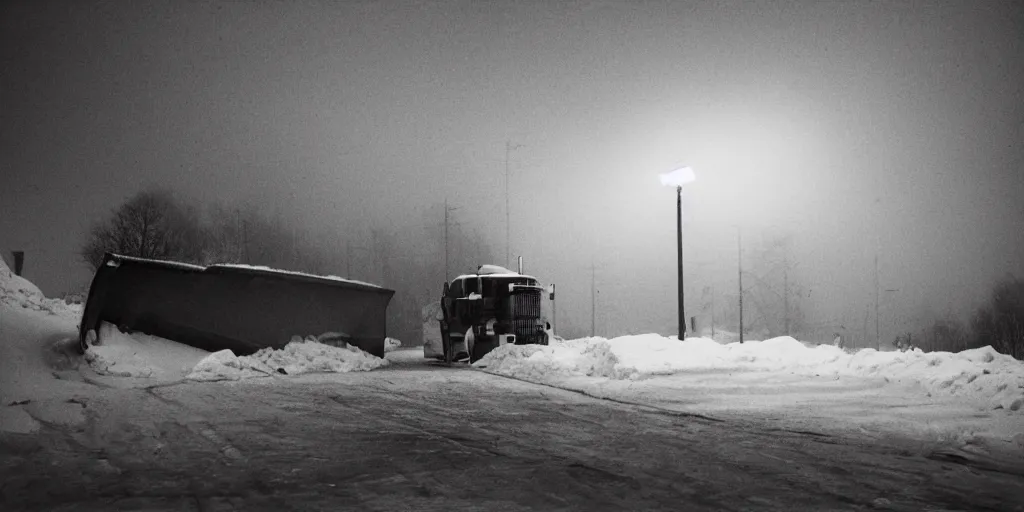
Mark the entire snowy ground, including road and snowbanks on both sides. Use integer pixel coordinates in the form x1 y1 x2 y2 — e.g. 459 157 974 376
0 262 1024 511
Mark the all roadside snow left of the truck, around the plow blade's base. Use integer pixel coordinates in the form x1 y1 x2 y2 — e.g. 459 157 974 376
0 259 393 433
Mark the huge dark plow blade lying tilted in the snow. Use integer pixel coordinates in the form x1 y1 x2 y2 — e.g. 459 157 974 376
79 254 394 357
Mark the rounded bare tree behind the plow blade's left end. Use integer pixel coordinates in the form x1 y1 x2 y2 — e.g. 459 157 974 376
81 189 206 269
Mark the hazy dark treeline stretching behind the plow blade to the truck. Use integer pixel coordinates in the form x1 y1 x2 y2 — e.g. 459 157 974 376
81 189 492 346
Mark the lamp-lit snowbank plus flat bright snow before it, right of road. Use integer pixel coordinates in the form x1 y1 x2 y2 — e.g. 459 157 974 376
476 335 1024 450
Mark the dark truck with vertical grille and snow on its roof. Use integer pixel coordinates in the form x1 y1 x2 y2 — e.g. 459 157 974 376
423 262 554 364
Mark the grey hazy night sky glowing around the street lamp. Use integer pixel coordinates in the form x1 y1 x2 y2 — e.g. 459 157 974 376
0 0 1024 342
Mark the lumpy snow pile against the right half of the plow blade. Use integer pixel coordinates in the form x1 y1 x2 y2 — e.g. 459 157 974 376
187 336 388 381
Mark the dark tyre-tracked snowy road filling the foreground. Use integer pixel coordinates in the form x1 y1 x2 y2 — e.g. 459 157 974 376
0 348 1024 510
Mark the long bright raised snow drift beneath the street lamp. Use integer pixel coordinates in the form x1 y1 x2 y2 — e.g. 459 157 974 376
475 334 1024 411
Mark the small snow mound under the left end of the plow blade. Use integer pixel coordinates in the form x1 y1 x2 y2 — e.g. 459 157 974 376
85 322 210 380
